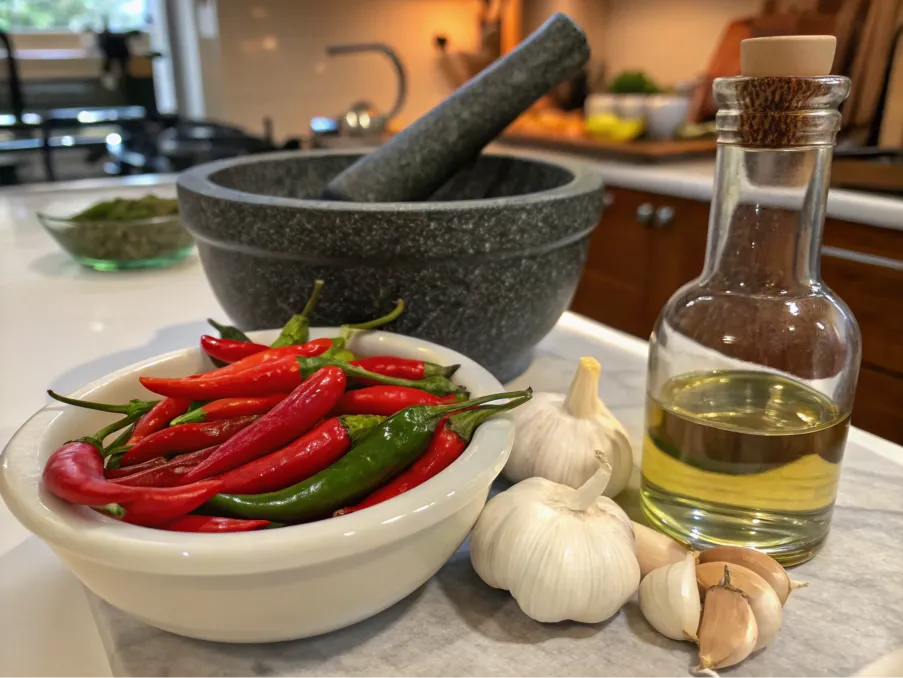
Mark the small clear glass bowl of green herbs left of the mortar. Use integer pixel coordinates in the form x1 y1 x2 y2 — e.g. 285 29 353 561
38 195 194 271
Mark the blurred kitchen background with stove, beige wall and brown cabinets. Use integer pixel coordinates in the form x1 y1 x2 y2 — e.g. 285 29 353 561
0 0 903 442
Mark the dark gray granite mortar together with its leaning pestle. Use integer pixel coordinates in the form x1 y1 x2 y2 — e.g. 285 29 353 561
178 14 603 381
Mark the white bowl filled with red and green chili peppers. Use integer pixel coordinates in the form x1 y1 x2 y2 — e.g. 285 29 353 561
0 317 530 642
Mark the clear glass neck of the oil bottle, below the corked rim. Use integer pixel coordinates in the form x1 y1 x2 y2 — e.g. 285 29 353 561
702 144 832 294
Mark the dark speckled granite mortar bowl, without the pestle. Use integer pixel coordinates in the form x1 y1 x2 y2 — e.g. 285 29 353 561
179 151 602 380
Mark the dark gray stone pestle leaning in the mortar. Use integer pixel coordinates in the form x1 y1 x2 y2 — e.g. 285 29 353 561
323 13 589 202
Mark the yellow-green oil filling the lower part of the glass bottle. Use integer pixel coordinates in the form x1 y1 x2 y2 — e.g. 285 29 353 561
641 371 850 564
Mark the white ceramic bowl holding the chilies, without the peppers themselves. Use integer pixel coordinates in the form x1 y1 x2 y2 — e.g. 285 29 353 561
0 328 514 643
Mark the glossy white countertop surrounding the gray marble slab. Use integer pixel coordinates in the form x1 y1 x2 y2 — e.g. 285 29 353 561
0 177 903 678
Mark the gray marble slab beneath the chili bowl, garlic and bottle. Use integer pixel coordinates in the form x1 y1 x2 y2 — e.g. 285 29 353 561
89 316 903 678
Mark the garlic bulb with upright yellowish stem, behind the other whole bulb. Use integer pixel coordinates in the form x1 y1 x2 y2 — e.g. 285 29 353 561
502 358 633 497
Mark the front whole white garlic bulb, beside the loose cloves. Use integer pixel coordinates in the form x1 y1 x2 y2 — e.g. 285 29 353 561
470 452 640 623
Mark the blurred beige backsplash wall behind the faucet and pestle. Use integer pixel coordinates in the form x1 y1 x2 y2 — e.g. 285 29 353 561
205 0 762 138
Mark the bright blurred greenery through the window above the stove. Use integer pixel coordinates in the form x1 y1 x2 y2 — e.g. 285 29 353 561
0 0 148 33
